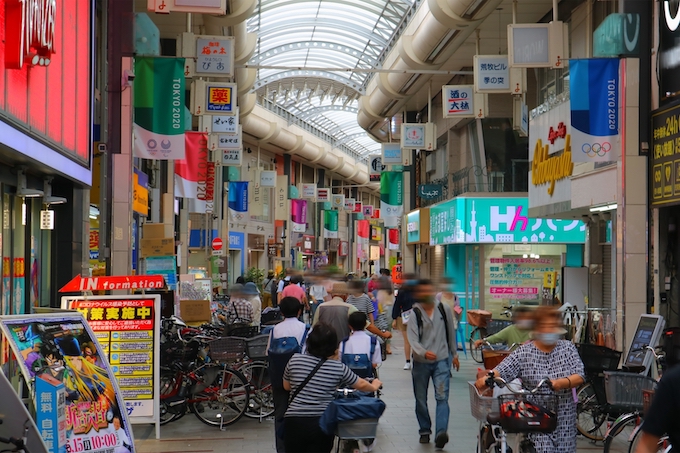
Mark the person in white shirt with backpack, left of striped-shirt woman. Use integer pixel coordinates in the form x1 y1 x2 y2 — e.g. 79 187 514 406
267 297 308 453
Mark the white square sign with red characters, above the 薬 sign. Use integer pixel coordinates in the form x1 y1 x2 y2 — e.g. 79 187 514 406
195 35 234 77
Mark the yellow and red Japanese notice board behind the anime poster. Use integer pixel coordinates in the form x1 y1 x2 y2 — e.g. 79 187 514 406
62 294 161 422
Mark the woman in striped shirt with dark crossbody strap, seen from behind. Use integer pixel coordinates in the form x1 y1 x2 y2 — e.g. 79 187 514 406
283 323 382 453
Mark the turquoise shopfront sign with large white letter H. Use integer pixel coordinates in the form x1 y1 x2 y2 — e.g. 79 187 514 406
430 197 586 245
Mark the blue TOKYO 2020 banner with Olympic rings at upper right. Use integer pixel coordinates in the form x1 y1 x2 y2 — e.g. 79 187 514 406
569 58 621 162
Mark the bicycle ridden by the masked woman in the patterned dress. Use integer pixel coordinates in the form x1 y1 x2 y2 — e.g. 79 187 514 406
469 373 557 453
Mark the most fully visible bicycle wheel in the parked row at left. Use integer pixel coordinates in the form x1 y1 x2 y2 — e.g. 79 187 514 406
191 366 249 427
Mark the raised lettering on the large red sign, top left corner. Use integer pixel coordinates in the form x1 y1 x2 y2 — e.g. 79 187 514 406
5 0 57 69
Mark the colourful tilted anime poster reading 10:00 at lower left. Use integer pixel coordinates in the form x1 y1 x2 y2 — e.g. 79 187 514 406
0 313 135 453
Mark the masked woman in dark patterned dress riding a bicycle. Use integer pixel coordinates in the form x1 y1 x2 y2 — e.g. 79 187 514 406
476 306 584 453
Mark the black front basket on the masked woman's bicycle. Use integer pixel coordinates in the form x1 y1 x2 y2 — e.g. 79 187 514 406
498 393 557 433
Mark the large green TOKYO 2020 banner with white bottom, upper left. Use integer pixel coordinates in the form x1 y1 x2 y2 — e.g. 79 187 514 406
133 57 185 160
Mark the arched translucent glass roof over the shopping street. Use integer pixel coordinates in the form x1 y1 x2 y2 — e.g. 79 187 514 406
248 0 416 159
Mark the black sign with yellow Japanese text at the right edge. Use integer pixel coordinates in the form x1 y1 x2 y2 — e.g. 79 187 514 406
651 101 680 206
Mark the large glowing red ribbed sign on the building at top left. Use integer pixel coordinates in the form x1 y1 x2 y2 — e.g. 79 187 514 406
0 0 94 162
